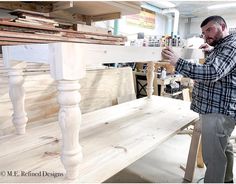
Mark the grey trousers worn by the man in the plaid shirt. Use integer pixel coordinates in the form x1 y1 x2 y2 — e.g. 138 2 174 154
200 114 236 183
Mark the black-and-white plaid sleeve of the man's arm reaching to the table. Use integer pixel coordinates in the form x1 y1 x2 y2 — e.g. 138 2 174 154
175 45 236 81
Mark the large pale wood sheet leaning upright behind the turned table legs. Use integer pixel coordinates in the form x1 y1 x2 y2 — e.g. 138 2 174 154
0 63 135 135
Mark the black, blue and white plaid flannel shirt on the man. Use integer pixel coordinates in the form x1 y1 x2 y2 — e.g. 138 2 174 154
176 34 236 119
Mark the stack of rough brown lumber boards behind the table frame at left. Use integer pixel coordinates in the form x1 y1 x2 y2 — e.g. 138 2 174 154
0 11 126 45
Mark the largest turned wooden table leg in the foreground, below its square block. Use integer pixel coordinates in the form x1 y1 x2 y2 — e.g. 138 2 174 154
58 80 82 179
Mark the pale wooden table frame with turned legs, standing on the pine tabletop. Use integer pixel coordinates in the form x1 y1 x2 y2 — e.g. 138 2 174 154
3 43 203 179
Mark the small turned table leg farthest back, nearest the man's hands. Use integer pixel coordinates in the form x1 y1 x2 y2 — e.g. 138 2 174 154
147 62 155 98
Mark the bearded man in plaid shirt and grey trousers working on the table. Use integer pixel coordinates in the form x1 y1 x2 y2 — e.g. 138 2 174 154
162 16 236 183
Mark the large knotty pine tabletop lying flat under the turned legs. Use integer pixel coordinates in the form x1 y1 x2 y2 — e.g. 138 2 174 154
0 96 198 183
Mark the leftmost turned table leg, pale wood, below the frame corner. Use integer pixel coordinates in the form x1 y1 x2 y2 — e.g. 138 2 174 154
8 68 28 134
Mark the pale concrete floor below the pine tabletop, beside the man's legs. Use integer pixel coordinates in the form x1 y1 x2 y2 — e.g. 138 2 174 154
105 135 205 183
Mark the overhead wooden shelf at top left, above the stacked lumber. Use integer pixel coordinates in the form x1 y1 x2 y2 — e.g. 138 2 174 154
0 1 141 23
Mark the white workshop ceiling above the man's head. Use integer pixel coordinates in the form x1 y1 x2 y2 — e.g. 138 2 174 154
150 0 236 18
